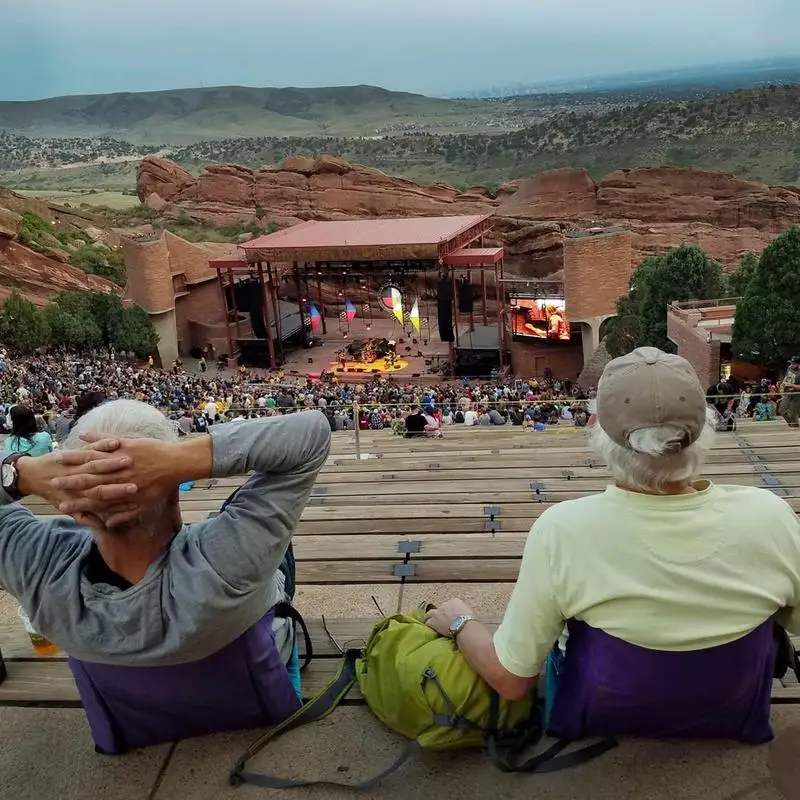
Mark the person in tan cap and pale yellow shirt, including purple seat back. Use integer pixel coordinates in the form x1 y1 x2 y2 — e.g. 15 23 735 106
428 347 800 743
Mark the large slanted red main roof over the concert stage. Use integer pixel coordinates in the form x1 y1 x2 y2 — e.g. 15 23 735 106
234 214 492 266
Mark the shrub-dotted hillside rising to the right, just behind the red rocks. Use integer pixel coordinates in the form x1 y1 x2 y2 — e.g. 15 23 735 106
166 86 800 184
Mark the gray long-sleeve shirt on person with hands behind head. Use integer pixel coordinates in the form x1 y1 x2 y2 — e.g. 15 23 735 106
0 412 331 666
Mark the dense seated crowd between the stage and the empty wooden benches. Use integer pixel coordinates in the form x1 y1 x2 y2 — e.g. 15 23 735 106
0 351 592 440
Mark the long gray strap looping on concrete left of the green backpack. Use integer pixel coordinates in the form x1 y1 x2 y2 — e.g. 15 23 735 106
229 649 420 789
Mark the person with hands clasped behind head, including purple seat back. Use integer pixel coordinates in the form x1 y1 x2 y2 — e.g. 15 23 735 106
0 400 330 753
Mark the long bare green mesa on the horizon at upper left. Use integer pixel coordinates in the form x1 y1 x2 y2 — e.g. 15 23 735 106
0 86 537 144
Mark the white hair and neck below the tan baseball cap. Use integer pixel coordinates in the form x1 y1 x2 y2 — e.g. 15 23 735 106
589 403 717 494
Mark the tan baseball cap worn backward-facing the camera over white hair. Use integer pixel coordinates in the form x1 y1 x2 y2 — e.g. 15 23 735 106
597 347 706 451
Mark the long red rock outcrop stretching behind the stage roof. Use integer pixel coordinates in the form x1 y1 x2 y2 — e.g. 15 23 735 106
138 156 800 277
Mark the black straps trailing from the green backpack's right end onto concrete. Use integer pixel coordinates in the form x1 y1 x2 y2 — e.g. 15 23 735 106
486 690 618 772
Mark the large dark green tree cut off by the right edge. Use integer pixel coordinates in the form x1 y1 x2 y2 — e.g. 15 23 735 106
732 228 800 369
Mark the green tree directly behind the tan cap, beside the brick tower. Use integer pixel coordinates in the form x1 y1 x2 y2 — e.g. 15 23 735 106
606 245 725 357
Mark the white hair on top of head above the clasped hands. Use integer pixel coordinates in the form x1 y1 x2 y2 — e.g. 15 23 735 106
63 400 178 450
